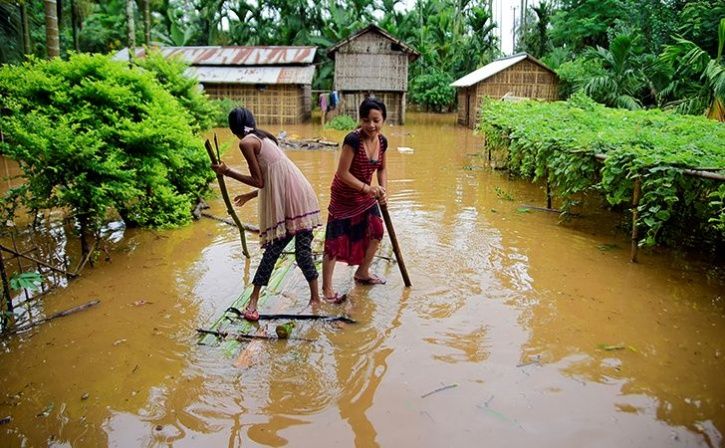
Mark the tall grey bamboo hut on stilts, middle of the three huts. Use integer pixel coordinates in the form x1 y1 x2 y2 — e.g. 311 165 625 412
328 25 420 124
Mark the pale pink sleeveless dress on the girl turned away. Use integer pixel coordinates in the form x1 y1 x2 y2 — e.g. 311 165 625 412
243 134 321 247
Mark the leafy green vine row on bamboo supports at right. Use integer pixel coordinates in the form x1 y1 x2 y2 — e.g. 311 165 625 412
478 94 725 247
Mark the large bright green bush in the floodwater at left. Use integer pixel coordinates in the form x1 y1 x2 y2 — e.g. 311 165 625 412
0 55 213 252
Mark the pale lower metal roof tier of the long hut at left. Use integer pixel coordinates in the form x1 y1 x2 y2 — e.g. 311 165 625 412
188 65 315 84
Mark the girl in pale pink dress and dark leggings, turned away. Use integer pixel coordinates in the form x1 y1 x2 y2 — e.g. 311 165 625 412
212 108 321 321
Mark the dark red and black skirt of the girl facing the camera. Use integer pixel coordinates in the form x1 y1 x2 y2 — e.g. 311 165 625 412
325 204 383 265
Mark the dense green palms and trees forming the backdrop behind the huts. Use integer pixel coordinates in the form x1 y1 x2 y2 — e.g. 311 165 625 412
0 0 725 119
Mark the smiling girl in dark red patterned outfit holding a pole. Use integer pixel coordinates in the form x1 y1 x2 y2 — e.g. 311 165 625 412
322 98 388 303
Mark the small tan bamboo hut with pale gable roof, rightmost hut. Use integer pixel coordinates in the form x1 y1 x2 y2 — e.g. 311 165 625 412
451 53 559 128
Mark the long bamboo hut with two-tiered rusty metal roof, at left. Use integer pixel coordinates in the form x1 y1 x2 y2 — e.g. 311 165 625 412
116 46 317 124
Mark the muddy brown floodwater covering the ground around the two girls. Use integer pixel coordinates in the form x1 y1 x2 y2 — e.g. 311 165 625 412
0 114 725 447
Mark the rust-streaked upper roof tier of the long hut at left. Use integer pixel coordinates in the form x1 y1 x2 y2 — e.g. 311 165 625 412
114 46 317 66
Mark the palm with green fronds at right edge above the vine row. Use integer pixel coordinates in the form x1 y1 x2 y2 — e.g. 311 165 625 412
660 19 725 121
